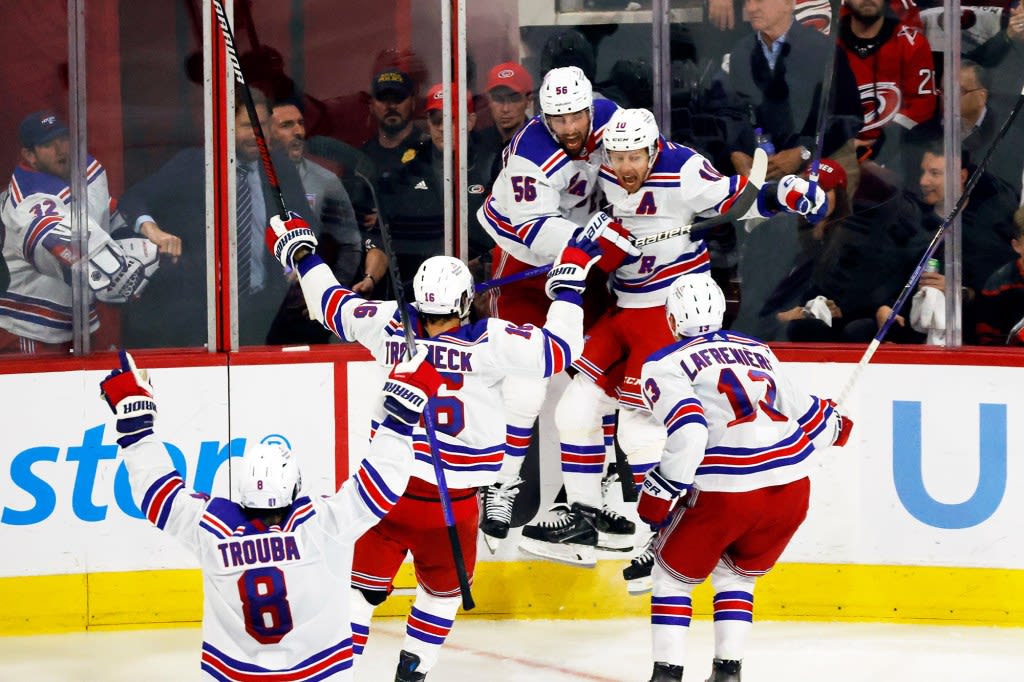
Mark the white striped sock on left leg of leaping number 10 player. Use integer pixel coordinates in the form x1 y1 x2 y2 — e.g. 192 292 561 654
555 374 615 508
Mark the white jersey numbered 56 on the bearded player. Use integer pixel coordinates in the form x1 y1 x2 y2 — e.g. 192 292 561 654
476 99 618 266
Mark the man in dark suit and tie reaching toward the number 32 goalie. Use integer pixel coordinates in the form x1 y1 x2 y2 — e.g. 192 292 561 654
120 90 319 347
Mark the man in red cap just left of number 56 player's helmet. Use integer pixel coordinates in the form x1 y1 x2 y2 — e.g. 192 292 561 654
479 61 534 183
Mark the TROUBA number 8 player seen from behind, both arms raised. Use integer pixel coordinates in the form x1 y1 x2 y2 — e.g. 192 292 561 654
100 348 437 682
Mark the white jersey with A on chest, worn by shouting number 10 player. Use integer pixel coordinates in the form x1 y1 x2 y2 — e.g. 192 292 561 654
600 138 762 308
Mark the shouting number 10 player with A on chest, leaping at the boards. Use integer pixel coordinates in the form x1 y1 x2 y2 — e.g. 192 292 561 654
520 109 826 569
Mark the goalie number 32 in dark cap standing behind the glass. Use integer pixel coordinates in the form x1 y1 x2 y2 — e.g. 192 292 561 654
0 112 165 353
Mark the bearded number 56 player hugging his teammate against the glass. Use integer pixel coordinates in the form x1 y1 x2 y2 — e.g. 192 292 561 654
477 67 635 550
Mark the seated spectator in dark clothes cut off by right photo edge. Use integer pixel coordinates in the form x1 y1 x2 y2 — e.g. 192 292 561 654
976 208 1024 345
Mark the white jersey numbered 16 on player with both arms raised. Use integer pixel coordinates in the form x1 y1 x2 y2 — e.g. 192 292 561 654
299 251 583 488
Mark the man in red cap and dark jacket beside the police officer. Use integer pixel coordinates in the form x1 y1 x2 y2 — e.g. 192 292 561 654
380 83 494 282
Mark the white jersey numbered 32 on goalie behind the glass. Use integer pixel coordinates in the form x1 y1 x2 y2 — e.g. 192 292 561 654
0 157 111 343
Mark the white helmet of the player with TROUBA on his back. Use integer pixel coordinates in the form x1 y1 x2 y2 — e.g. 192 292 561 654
237 443 302 509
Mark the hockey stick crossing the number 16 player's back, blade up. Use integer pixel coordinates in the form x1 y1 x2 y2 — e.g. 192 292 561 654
353 171 476 611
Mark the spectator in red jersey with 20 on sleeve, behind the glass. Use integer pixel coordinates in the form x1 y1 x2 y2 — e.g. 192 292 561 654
839 0 939 159
